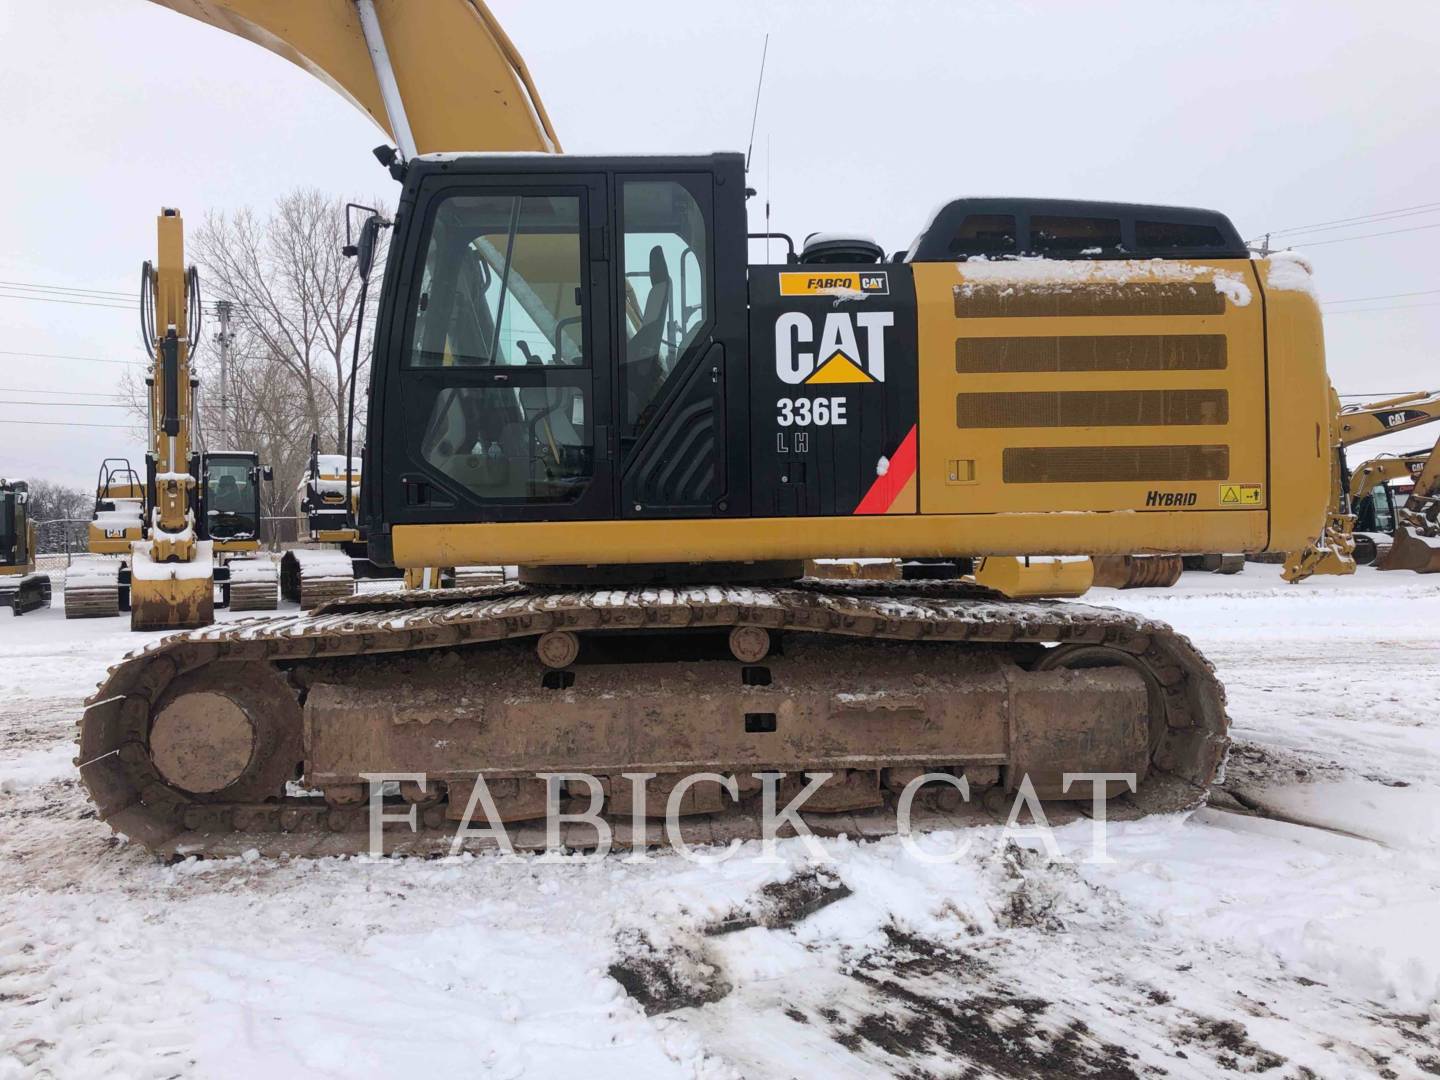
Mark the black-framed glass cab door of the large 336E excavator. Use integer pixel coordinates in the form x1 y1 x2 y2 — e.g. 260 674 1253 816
382 173 615 524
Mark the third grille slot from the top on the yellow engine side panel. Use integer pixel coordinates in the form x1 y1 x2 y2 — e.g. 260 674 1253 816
955 390 1230 428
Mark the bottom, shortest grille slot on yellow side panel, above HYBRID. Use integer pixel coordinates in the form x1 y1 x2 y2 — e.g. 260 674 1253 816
1002 446 1230 484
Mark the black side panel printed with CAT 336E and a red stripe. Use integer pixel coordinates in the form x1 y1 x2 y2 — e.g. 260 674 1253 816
750 264 919 517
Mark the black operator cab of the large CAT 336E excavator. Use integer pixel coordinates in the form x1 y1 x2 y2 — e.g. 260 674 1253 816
363 154 749 552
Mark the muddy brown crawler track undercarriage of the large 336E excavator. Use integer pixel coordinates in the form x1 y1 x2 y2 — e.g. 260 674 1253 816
78 580 1228 855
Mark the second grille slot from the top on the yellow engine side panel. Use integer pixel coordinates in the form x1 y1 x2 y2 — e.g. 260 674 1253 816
955 334 1227 374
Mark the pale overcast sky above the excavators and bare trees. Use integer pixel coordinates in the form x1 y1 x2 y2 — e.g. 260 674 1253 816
0 0 1440 487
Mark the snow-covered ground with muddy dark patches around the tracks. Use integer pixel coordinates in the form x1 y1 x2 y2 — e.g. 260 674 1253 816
0 566 1440 1080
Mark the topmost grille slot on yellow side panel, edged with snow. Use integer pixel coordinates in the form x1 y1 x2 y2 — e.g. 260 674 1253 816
955 281 1225 318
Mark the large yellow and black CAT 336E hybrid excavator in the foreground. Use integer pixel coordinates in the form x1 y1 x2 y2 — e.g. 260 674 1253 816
78 0 1332 854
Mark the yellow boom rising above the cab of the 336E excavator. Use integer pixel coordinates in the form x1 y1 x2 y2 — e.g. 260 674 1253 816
153 0 560 157
